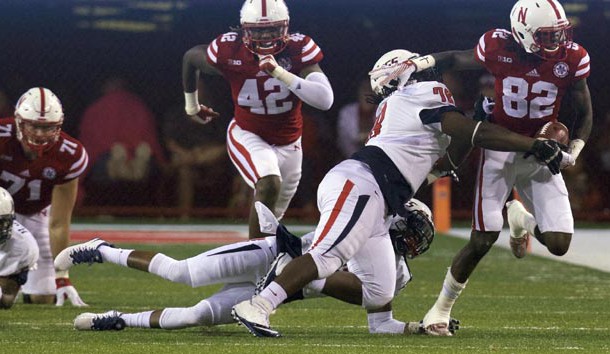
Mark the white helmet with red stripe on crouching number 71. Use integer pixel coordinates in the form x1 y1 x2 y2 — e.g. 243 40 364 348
15 87 64 153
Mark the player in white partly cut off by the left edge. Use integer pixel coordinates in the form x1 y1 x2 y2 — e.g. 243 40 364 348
0 187 38 309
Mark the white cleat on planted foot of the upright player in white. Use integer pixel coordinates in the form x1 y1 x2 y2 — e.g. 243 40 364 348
231 296 281 338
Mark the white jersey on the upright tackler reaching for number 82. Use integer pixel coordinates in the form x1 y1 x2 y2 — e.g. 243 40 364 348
366 81 457 190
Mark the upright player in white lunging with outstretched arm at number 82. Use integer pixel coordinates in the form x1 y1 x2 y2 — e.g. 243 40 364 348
233 50 562 337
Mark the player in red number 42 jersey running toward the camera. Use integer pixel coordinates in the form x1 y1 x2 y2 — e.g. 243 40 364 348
182 0 334 238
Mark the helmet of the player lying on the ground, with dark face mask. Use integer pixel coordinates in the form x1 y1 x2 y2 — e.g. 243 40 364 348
390 198 434 259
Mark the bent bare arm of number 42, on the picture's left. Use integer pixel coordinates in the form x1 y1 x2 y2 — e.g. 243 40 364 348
182 45 220 124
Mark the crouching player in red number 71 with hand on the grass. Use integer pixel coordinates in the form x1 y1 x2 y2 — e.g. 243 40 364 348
0 87 88 306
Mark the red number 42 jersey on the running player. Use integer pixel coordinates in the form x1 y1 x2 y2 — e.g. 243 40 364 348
207 32 324 145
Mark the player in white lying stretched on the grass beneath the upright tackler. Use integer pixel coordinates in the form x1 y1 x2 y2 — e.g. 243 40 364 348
55 201 457 334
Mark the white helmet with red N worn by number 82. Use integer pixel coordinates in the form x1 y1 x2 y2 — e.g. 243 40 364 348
510 0 572 60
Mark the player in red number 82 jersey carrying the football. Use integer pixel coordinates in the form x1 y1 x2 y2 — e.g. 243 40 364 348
376 0 593 335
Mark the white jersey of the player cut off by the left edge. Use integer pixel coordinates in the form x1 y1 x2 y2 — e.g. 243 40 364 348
0 221 38 277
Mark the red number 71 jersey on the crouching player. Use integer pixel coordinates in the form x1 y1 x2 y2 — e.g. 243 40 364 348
0 118 89 215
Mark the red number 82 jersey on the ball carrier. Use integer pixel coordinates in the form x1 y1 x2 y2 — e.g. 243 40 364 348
475 29 590 136
